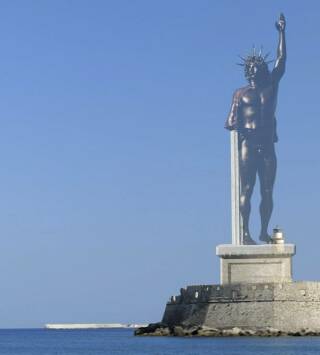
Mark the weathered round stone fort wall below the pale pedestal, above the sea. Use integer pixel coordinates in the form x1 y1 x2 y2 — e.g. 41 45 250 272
162 282 320 336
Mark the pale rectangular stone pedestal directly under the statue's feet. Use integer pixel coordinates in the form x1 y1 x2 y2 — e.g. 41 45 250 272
216 244 295 285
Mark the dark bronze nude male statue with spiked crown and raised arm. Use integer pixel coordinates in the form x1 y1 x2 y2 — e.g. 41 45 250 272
225 14 286 248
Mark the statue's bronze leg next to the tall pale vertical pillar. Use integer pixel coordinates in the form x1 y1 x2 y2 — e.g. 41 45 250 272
239 139 257 244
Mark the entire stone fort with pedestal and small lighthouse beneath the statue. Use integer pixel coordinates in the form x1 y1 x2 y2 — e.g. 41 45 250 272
143 239 320 336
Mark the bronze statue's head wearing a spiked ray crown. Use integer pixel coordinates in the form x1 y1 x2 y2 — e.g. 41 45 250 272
239 49 272 84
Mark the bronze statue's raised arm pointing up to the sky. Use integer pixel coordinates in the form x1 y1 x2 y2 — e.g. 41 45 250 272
272 14 287 81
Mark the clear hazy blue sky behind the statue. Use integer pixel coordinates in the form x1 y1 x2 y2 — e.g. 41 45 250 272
0 0 320 327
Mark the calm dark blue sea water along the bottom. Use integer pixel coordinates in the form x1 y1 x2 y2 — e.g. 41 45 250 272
0 329 320 355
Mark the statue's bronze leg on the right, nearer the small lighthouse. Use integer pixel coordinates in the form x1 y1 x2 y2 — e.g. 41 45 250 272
258 144 277 243
